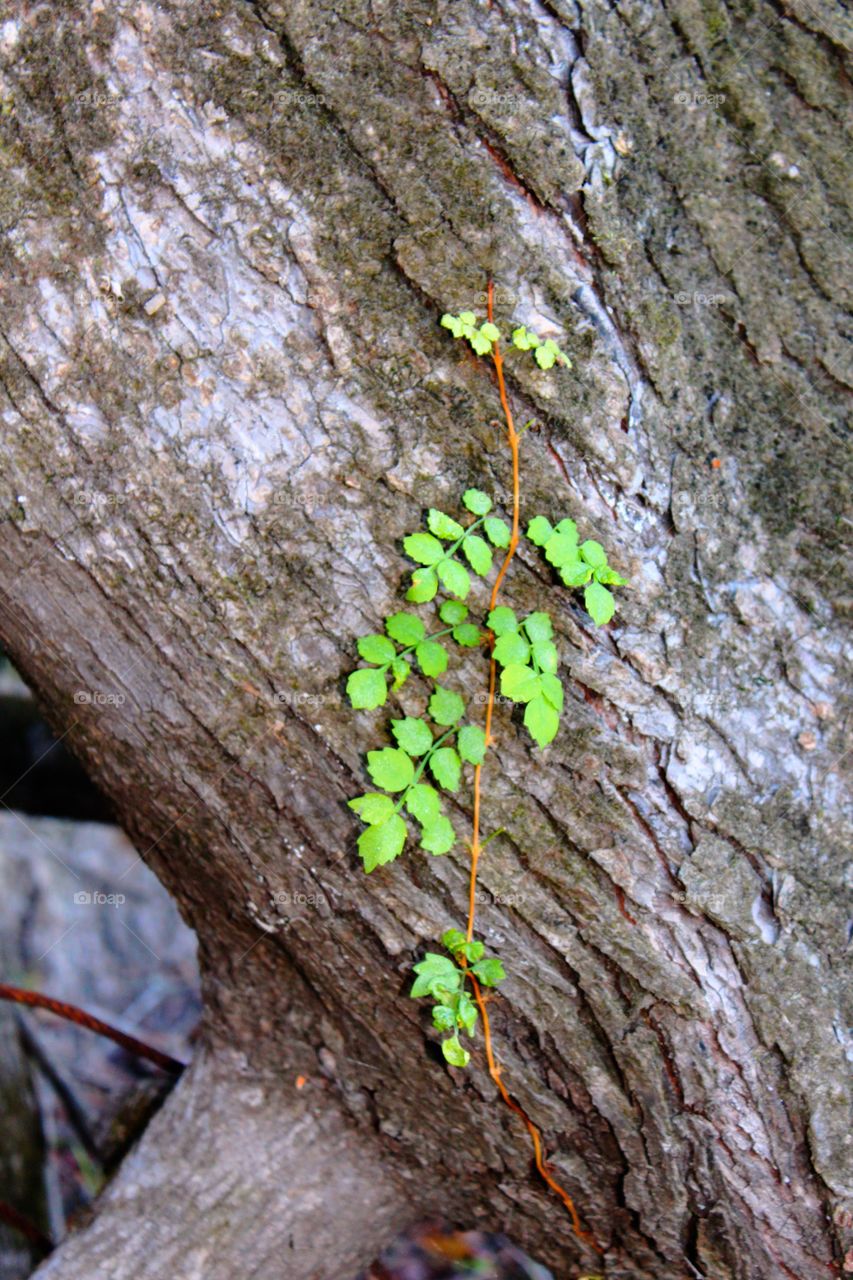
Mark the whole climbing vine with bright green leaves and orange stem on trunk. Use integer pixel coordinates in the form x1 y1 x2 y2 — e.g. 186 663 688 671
347 284 625 1239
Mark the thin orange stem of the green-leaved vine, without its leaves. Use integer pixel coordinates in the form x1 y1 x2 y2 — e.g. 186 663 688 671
462 280 602 1253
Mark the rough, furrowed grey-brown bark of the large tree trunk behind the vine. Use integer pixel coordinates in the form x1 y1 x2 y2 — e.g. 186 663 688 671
0 0 849 1280
